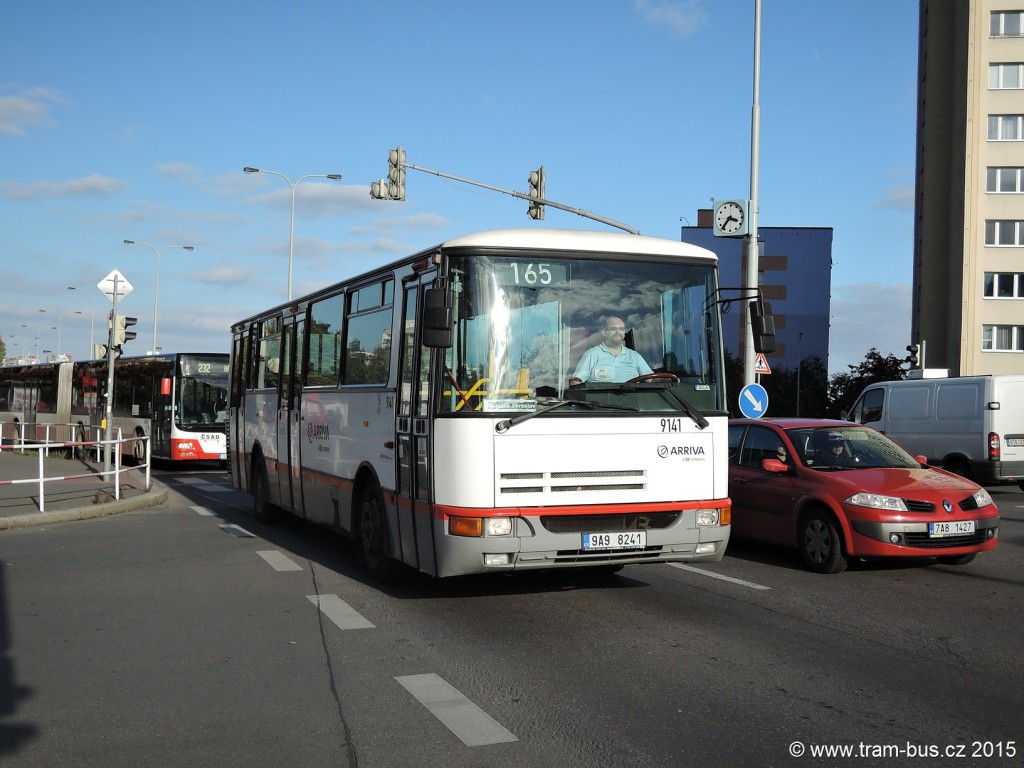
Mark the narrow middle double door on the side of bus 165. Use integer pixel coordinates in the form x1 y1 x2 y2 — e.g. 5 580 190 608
278 315 305 514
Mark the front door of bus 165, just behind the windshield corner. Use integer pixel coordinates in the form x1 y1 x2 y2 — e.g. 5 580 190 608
395 275 437 573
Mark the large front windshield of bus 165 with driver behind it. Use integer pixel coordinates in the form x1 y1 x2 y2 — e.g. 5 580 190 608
440 252 724 415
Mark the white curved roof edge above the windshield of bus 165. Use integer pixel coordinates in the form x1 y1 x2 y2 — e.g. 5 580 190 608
440 228 718 261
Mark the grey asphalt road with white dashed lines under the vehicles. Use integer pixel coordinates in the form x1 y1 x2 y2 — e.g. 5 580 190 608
0 472 1024 768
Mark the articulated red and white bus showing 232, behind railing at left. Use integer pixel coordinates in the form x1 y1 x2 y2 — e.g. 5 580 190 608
0 352 228 462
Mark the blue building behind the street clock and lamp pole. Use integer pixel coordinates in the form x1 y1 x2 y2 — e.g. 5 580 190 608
680 209 833 370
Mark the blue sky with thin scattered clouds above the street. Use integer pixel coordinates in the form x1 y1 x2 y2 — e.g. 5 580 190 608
0 0 919 373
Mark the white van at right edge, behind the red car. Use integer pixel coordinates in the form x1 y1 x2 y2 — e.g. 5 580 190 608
847 375 1024 489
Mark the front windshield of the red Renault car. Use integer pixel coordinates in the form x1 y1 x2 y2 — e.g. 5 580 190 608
785 426 921 470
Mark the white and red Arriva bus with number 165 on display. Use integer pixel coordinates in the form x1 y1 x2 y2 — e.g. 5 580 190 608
227 229 731 577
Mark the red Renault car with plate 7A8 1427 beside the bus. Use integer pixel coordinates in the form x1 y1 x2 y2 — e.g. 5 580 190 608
729 419 999 573
